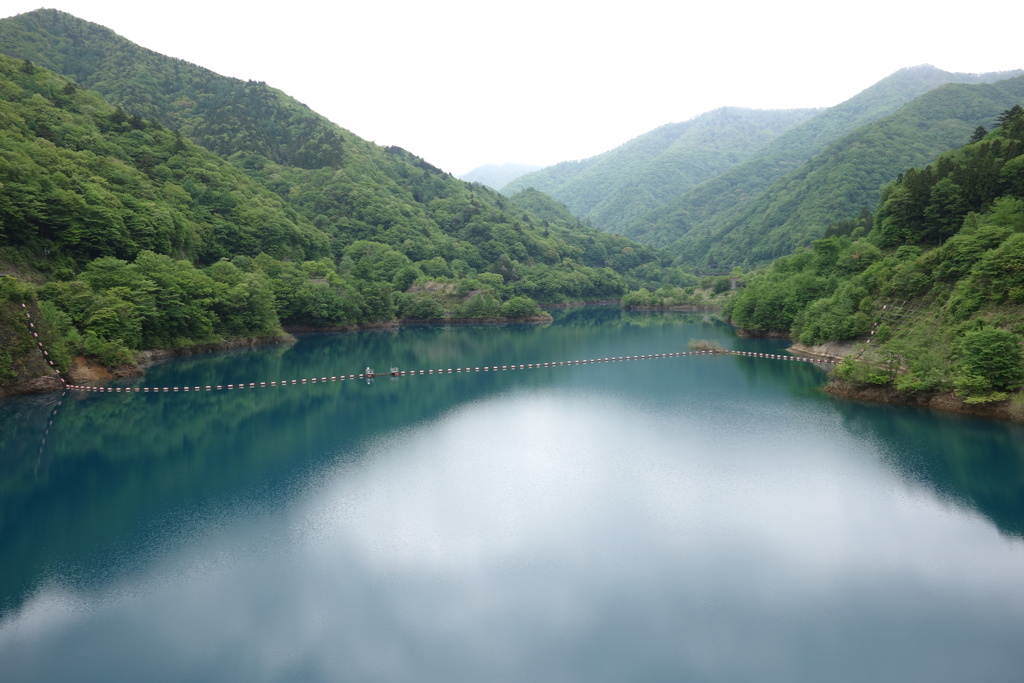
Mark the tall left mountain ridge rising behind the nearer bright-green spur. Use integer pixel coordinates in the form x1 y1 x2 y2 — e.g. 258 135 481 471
0 10 652 288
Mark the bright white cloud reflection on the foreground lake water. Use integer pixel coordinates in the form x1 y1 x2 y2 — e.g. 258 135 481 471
0 392 1024 681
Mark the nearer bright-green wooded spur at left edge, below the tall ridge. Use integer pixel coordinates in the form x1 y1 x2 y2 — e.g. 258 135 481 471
0 57 329 273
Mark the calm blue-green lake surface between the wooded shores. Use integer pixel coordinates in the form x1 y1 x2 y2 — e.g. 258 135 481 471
0 309 1024 681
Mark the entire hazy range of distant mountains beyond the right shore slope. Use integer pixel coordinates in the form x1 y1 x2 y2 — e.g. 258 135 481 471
502 65 1024 270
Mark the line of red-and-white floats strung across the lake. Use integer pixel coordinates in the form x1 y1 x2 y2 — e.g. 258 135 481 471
22 303 837 394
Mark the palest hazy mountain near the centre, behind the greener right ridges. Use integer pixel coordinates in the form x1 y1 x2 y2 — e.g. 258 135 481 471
502 108 815 232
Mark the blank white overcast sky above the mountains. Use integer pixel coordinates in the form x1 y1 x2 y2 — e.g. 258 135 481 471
0 0 1024 175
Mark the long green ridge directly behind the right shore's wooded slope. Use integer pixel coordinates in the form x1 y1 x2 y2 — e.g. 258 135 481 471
670 76 1024 270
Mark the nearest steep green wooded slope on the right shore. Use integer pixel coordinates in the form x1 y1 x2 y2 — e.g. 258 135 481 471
727 105 1024 405
